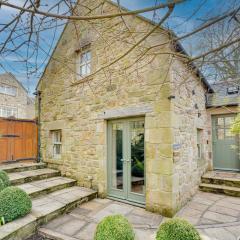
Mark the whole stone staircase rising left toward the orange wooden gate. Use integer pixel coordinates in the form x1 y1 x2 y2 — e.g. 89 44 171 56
0 163 97 240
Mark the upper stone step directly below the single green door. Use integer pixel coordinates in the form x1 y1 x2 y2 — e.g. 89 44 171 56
202 174 240 188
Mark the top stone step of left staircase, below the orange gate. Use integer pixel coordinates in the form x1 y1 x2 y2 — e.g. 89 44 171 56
0 163 47 173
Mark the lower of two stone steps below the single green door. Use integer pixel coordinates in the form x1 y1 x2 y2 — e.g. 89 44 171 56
199 183 240 197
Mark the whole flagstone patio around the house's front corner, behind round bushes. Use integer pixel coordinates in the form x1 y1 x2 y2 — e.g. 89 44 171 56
41 192 240 240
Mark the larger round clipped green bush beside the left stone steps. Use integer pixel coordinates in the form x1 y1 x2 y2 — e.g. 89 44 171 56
0 187 32 222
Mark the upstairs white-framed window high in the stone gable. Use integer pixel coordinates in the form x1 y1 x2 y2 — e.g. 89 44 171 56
77 49 92 79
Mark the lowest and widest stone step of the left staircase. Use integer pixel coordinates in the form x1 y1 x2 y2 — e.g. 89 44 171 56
0 186 97 240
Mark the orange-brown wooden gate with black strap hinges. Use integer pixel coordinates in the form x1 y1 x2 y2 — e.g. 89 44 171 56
0 118 37 163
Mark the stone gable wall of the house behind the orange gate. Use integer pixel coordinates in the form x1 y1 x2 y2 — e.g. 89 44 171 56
0 73 35 119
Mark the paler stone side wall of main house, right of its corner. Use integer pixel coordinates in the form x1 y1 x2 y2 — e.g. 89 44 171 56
171 60 211 211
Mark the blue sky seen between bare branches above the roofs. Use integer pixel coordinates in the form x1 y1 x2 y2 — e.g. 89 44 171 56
0 0 237 94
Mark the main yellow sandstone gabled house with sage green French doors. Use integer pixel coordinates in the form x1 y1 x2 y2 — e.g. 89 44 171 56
37 0 240 216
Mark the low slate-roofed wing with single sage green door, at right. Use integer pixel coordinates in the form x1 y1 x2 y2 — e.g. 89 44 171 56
206 79 240 171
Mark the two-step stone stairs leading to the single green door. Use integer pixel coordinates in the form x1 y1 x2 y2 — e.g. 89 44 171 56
199 171 240 197
